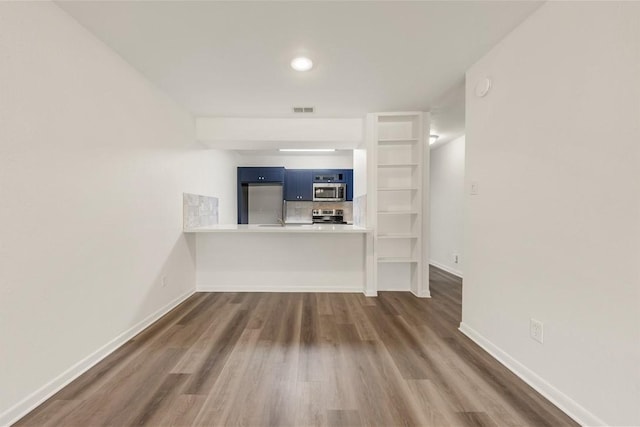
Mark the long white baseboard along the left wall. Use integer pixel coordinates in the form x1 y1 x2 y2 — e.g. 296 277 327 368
0 290 194 426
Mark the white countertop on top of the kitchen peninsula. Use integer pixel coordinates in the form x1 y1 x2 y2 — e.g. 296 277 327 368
184 224 371 233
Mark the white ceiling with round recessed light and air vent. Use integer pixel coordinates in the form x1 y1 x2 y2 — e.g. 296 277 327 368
56 1 541 140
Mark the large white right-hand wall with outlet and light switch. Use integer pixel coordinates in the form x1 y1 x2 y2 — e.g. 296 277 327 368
462 2 640 425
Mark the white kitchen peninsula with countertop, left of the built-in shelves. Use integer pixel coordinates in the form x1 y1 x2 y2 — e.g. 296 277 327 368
184 224 376 296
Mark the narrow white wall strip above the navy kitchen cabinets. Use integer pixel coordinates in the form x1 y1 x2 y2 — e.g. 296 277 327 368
237 150 353 169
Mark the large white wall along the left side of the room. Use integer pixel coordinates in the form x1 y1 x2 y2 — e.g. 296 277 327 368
0 2 235 425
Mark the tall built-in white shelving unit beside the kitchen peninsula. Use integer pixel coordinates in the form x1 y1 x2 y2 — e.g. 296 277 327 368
367 112 429 297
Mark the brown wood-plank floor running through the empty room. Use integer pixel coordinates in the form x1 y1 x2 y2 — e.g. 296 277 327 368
16 269 577 427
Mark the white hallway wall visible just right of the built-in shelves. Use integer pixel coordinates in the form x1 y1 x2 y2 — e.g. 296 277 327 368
429 136 464 277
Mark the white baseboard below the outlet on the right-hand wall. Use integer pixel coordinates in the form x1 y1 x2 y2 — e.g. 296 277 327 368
458 323 608 426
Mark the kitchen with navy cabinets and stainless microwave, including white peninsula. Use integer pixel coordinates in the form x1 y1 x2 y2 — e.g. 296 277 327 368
184 150 376 296
